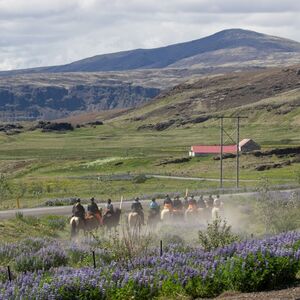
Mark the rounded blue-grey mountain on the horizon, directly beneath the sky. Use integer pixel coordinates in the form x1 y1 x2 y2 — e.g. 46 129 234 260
2 29 300 75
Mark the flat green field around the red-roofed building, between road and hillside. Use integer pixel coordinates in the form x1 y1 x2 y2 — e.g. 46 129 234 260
0 116 300 208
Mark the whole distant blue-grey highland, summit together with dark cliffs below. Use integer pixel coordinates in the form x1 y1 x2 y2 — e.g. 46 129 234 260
0 29 300 121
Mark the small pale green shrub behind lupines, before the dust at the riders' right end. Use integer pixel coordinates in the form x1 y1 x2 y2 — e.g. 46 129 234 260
199 218 239 251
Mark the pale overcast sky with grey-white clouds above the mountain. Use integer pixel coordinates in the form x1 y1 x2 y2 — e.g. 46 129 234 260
0 0 300 70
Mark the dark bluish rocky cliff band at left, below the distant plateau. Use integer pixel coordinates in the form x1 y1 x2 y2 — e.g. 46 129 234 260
0 77 160 121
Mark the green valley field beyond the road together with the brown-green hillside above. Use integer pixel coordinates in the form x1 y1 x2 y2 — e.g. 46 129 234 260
0 66 300 208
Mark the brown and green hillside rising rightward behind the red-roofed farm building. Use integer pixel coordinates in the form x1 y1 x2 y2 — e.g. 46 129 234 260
117 65 300 126
